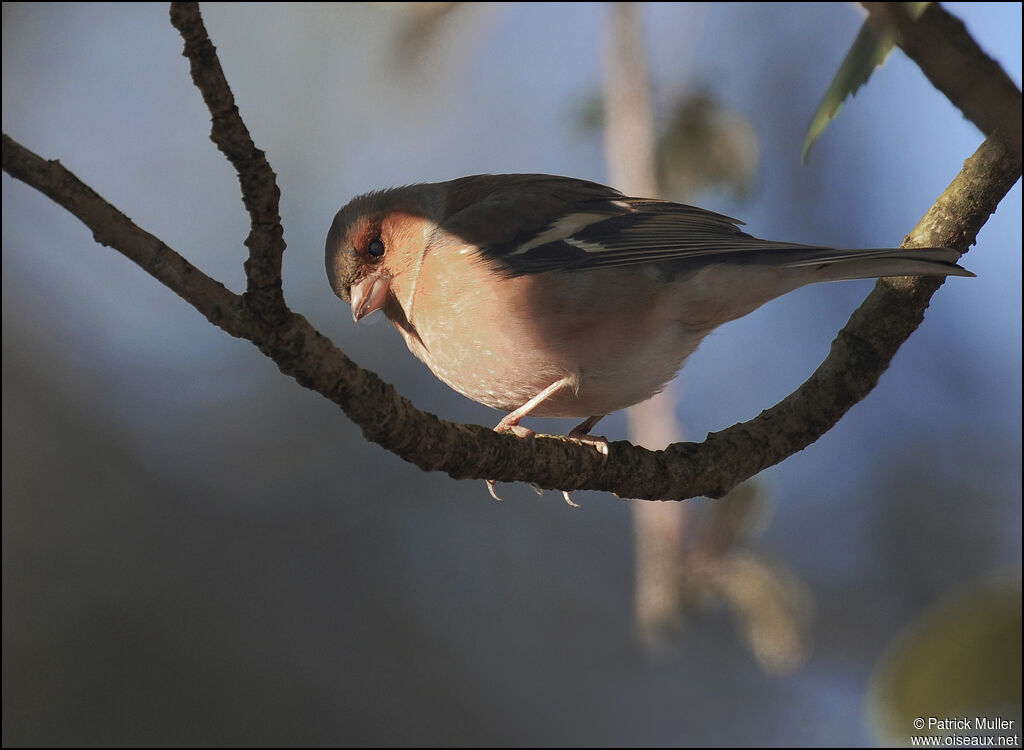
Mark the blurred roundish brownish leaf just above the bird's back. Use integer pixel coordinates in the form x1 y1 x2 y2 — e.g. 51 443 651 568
657 93 760 202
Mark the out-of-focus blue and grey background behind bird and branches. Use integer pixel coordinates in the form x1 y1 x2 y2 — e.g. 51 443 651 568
2 3 1021 745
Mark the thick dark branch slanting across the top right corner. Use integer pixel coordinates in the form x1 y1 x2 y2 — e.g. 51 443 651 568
863 2 1021 161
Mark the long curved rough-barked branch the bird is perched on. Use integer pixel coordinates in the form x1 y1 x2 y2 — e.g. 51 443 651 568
3 2 1021 500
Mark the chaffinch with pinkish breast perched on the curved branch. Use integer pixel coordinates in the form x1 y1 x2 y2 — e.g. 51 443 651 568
326 174 974 502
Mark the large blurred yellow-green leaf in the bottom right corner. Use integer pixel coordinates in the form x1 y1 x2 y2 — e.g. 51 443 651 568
868 570 1021 745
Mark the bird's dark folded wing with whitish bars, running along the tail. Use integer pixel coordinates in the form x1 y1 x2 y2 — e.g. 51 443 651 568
441 174 962 276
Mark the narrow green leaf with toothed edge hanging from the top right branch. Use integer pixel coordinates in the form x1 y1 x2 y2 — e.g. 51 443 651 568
800 2 931 162
